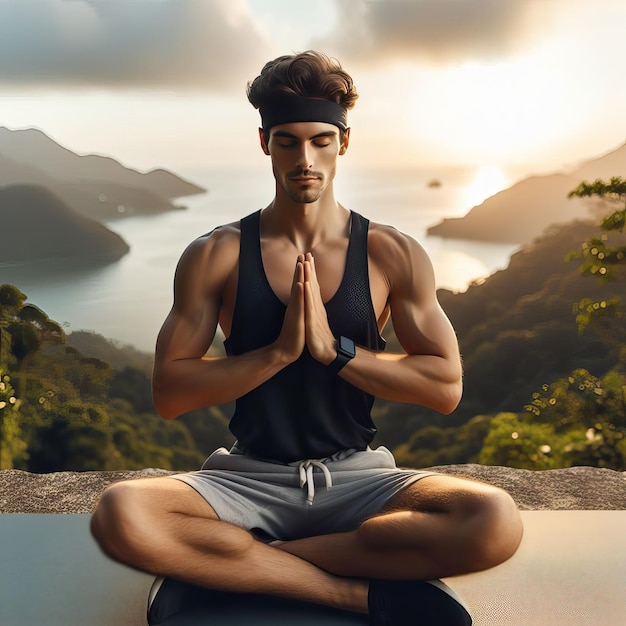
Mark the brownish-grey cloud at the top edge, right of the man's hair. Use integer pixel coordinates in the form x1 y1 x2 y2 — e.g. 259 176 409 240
314 0 560 64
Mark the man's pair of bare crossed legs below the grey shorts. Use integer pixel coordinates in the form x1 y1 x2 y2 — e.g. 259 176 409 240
92 476 522 613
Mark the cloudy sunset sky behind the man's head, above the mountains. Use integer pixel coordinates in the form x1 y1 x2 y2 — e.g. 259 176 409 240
0 0 626 190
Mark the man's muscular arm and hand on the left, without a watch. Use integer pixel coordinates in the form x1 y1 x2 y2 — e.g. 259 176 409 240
152 227 304 419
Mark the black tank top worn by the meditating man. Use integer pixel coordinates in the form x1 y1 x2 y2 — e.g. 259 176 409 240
224 211 385 463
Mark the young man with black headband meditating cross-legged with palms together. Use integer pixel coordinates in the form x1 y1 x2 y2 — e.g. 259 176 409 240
92 52 522 625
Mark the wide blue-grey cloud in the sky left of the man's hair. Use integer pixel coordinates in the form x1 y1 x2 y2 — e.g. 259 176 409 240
0 0 269 92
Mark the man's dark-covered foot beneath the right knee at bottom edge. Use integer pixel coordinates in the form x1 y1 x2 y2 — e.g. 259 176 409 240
368 580 472 626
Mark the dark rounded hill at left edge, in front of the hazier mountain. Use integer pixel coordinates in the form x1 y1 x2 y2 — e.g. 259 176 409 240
0 185 129 264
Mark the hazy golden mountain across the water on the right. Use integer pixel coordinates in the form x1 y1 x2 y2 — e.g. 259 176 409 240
428 144 626 243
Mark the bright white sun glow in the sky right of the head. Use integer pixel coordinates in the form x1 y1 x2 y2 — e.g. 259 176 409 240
407 51 573 164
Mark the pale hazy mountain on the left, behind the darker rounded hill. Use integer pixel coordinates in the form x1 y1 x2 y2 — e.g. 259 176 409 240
0 127 206 219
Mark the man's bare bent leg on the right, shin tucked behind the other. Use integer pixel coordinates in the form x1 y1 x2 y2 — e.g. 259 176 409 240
272 476 523 580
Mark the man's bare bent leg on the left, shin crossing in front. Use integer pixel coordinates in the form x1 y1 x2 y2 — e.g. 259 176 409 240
91 478 368 613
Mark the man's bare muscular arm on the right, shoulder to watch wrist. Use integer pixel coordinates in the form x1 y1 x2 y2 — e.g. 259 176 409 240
305 227 462 414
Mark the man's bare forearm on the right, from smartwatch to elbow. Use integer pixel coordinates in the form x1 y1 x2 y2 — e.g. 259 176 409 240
339 347 462 414
